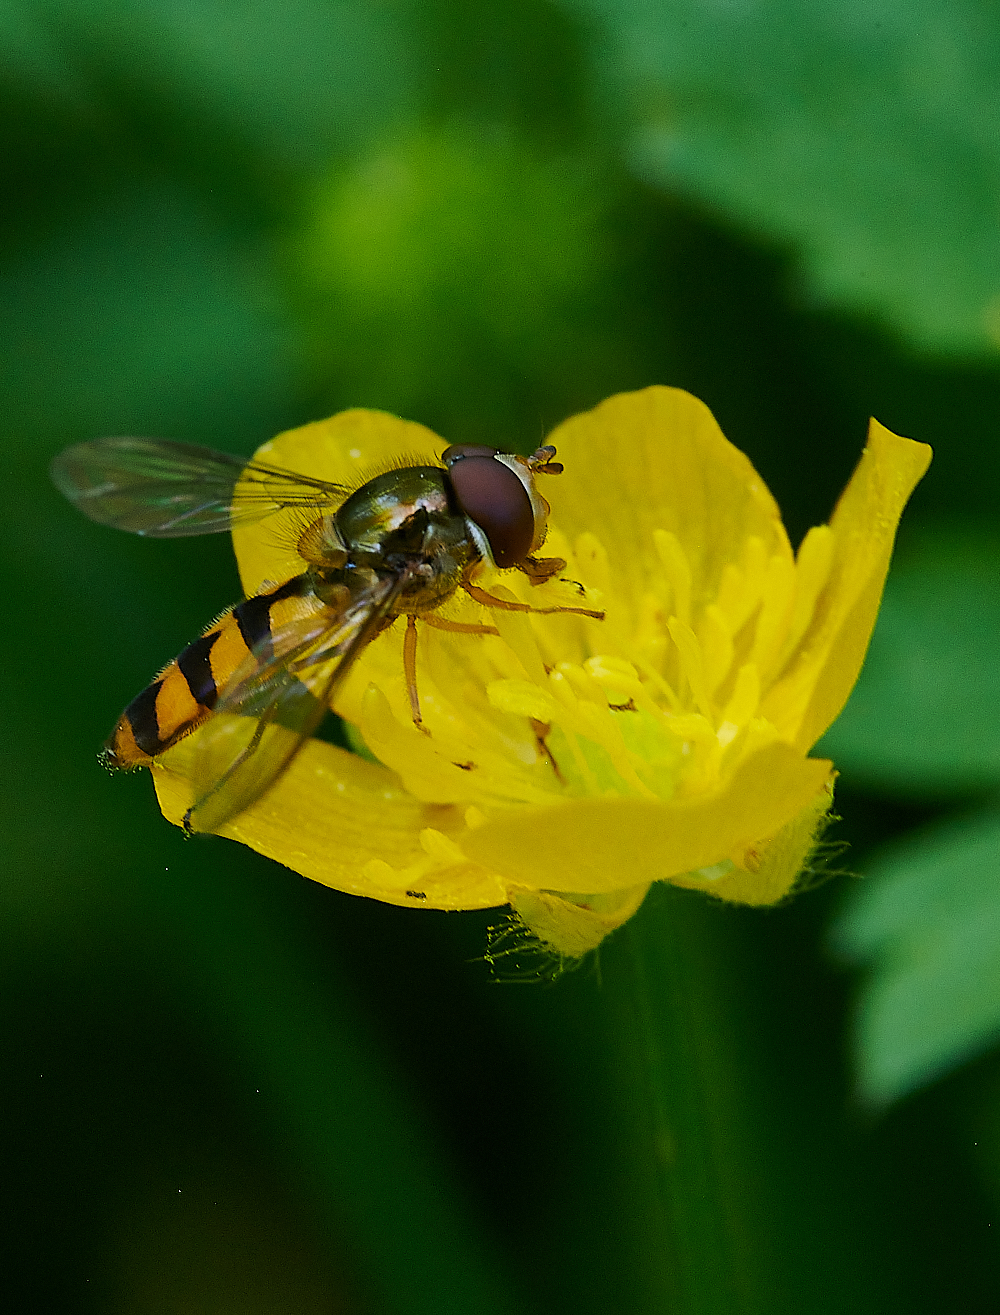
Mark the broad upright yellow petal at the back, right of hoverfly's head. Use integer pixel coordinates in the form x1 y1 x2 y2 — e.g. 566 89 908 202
534 388 791 619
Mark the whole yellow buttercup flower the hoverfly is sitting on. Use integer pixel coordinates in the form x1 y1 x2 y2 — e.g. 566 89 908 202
154 388 930 956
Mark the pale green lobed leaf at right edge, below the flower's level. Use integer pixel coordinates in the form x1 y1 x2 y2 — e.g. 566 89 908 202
834 814 1000 1105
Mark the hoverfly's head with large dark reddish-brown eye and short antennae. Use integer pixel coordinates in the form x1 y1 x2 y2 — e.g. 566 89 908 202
442 443 555 567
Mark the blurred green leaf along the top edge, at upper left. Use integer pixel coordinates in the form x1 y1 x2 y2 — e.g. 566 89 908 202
7 0 414 166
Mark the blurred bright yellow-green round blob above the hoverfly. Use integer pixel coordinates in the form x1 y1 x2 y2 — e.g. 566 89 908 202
291 125 621 444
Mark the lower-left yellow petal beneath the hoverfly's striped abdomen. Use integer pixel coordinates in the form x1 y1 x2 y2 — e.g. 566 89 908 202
153 732 508 909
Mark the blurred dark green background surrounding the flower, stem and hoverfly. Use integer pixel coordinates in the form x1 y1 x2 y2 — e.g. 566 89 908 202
0 0 1000 1315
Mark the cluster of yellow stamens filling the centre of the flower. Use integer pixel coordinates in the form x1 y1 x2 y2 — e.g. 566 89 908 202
344 515 833 810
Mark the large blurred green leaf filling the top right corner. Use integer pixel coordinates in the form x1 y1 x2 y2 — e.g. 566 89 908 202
563 0 1000 352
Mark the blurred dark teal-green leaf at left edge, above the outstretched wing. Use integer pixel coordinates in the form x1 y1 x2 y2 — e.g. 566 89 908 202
0 184 292 447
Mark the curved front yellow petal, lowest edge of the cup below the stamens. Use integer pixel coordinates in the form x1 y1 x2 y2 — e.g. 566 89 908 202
462 742 830 893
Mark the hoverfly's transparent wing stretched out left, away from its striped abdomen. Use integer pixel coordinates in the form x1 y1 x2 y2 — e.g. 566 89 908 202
51 438 347 539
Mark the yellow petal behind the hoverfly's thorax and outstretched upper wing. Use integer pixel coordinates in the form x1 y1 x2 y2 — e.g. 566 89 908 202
233 410 447 597
